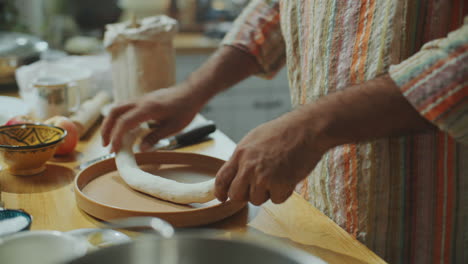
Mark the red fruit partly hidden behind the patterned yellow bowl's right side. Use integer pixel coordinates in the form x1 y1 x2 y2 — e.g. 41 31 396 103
44 116 79 155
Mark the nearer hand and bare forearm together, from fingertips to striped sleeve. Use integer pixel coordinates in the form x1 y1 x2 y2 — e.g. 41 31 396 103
215 75 434 205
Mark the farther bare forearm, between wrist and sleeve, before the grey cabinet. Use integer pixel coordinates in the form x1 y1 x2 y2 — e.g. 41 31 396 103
184 46 260 104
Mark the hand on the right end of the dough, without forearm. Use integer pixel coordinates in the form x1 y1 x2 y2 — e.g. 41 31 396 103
215 110 323 205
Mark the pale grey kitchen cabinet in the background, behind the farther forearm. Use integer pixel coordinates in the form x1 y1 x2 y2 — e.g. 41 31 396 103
176 54 291 142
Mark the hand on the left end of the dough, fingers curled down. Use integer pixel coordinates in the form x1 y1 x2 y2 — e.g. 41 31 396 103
101 85 203 152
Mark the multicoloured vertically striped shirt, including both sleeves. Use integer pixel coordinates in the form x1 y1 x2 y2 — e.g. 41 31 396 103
223 0 468 263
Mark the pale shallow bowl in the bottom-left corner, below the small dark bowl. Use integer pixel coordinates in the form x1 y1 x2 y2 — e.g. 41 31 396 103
0 231 87 264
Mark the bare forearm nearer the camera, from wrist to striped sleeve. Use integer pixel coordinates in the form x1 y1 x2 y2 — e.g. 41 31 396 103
293 75 435 150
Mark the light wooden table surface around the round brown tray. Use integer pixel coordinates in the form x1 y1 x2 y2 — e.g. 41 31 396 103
0 103 385 263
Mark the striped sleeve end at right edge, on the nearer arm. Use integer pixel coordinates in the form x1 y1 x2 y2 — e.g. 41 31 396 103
389 17 468 144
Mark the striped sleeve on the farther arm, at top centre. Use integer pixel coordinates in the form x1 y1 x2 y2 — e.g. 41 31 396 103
222 0 286 79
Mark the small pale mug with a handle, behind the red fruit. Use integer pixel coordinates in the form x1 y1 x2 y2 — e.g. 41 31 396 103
32 77 80 119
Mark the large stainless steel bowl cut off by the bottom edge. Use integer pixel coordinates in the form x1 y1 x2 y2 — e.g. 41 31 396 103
70 232 325 264
